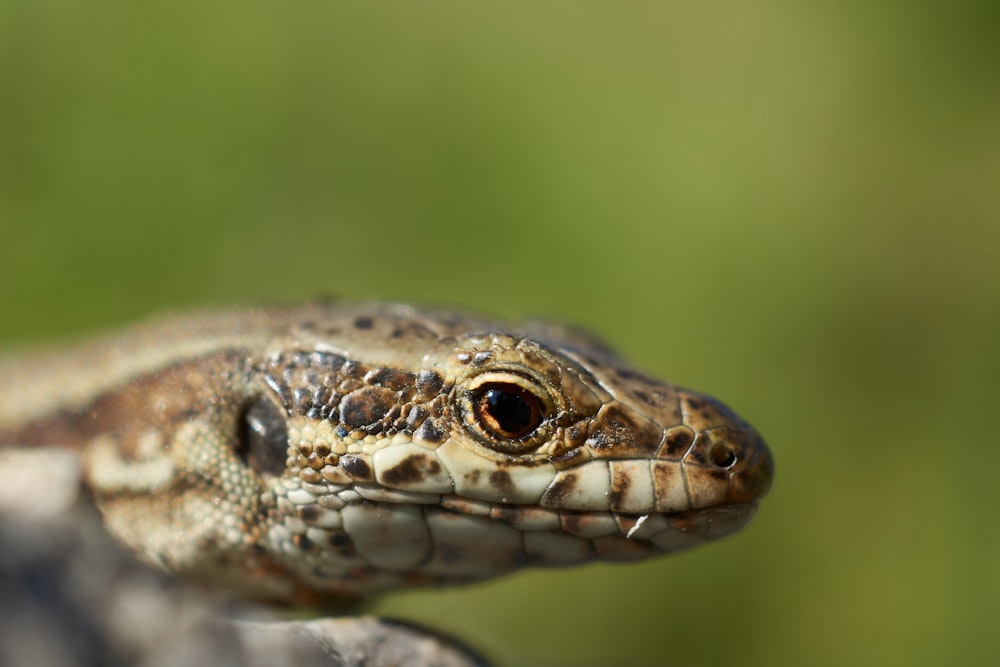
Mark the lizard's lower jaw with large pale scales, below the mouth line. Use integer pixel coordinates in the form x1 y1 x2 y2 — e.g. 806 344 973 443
252 486 757 597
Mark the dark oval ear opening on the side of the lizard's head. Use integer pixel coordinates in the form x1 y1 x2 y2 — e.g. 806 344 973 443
236 396 288 477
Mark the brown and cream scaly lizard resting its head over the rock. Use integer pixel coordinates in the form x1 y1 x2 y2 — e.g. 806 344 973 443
0 304 773 605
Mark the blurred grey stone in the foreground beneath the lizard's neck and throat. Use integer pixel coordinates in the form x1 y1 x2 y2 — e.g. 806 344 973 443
0 451 488 667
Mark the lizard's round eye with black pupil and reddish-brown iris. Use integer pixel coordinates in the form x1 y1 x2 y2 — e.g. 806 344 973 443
460 371 555 454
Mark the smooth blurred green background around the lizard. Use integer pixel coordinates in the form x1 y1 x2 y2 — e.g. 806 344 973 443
0 0 1000 666
